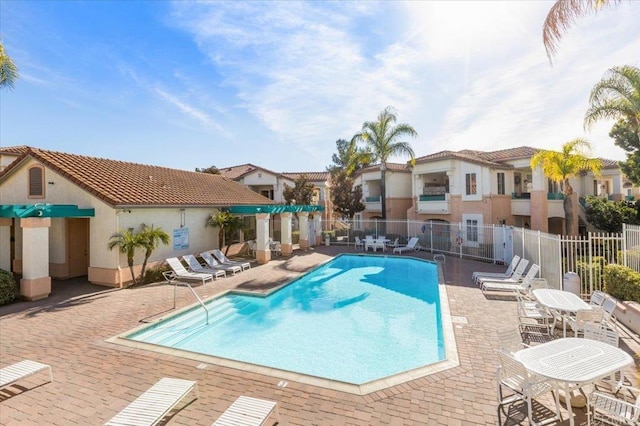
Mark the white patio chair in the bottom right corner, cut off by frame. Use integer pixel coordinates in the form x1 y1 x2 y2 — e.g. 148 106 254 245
587 388 640 426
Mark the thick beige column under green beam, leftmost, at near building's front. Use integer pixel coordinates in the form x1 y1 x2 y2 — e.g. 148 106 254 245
20 217 51 300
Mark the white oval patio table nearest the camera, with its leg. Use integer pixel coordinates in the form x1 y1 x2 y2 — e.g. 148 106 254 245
514 337 633 425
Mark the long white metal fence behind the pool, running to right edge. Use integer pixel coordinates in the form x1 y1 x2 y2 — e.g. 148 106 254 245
325 220 640 297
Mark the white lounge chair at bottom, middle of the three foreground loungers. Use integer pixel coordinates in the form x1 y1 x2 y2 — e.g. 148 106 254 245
105 377 199 425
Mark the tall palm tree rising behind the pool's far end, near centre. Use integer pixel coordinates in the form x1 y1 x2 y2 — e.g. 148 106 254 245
352 107 418 220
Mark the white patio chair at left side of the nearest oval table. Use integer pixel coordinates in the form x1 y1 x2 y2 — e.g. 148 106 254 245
497 351 560 424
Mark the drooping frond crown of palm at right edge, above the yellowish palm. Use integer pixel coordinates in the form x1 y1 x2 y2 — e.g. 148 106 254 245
584 65 640 141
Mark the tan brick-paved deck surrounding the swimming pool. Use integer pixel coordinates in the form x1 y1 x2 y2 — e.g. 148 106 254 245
0 246 640 425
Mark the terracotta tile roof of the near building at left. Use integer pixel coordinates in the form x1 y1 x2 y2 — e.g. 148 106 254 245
0 148 273 206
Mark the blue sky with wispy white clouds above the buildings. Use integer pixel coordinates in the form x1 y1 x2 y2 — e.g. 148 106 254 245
0 0 640 172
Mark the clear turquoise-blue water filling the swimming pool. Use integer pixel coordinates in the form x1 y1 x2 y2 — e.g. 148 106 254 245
127 255 445 384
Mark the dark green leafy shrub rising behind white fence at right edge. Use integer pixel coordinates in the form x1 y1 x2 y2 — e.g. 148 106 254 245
586 196 640 232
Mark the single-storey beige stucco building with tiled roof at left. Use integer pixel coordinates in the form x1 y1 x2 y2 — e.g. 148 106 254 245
0 146 274 299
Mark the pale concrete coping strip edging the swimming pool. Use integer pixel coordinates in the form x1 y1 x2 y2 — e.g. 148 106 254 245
105 254 460 396
